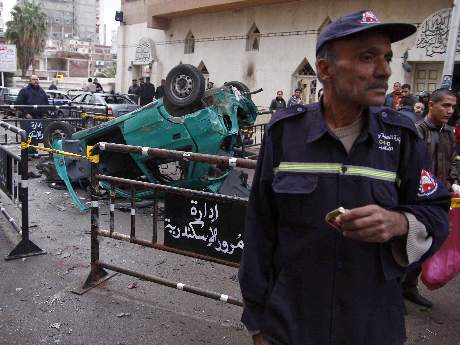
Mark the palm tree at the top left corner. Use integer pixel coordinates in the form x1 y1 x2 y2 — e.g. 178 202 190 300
5 0 48 77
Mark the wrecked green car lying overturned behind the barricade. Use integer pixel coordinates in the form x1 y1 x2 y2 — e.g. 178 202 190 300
53 64 261 204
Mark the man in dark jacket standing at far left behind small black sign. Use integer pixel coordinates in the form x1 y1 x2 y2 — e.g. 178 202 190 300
16 74 49 119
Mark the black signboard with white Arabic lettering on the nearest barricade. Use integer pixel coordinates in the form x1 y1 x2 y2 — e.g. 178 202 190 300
164 194 246 263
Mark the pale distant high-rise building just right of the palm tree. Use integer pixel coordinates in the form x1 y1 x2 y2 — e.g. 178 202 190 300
18 0 101 43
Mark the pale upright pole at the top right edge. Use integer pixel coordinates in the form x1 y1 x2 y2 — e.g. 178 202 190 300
441 0 460 89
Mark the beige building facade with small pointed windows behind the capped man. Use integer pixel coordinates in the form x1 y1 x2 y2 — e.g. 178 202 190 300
117 0 460 106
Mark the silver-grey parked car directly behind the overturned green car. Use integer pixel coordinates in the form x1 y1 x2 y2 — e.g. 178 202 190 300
71 92 140 117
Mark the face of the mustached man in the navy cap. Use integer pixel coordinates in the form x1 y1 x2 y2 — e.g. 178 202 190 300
330 31 393 106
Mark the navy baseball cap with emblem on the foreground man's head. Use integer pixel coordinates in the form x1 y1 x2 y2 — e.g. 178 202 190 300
316 10 417 55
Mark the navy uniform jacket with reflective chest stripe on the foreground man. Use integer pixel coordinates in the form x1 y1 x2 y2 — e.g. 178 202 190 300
239 103 450 345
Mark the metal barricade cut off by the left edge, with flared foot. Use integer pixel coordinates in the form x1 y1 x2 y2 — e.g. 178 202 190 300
0 121 46 260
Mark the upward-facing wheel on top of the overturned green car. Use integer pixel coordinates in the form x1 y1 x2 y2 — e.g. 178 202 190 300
164 64 205 110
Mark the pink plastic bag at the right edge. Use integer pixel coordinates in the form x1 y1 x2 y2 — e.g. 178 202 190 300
421 204 460 290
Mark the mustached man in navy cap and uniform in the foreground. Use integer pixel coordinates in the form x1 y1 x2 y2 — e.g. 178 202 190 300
239 11 450 345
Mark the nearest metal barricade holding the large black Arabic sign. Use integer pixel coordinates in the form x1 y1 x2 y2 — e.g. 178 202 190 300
74 143 256 306
